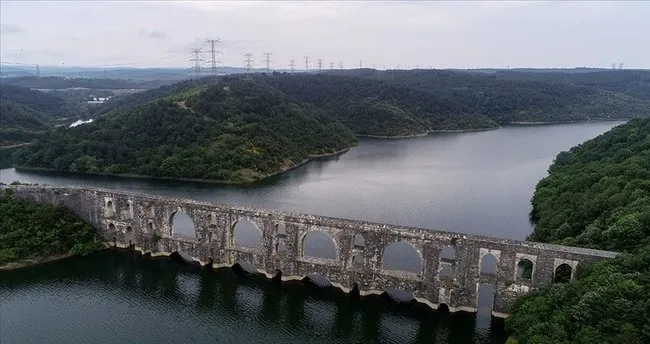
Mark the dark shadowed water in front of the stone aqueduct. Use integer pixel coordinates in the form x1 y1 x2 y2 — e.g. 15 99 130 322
0 251 505 343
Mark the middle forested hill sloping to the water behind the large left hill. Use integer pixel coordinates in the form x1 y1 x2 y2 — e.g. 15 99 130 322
256 73 497 136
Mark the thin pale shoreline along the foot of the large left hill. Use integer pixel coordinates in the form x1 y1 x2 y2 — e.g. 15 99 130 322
13 146 354 185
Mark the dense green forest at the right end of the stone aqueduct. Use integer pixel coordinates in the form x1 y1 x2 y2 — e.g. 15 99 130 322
507 119 650 344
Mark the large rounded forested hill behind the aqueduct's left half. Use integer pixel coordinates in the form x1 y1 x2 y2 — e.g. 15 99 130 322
14 79 357 182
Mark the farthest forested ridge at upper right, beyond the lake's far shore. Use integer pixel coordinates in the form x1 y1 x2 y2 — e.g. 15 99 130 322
329 69 650 124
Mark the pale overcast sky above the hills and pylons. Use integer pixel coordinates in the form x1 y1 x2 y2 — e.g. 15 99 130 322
0 0 650 69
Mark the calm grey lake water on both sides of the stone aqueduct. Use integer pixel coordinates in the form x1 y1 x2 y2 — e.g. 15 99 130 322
0 122 621 343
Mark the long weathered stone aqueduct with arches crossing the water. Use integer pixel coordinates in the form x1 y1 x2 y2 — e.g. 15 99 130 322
13 186 617 316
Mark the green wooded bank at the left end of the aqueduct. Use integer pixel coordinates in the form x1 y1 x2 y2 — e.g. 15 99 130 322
0 189 103 266
